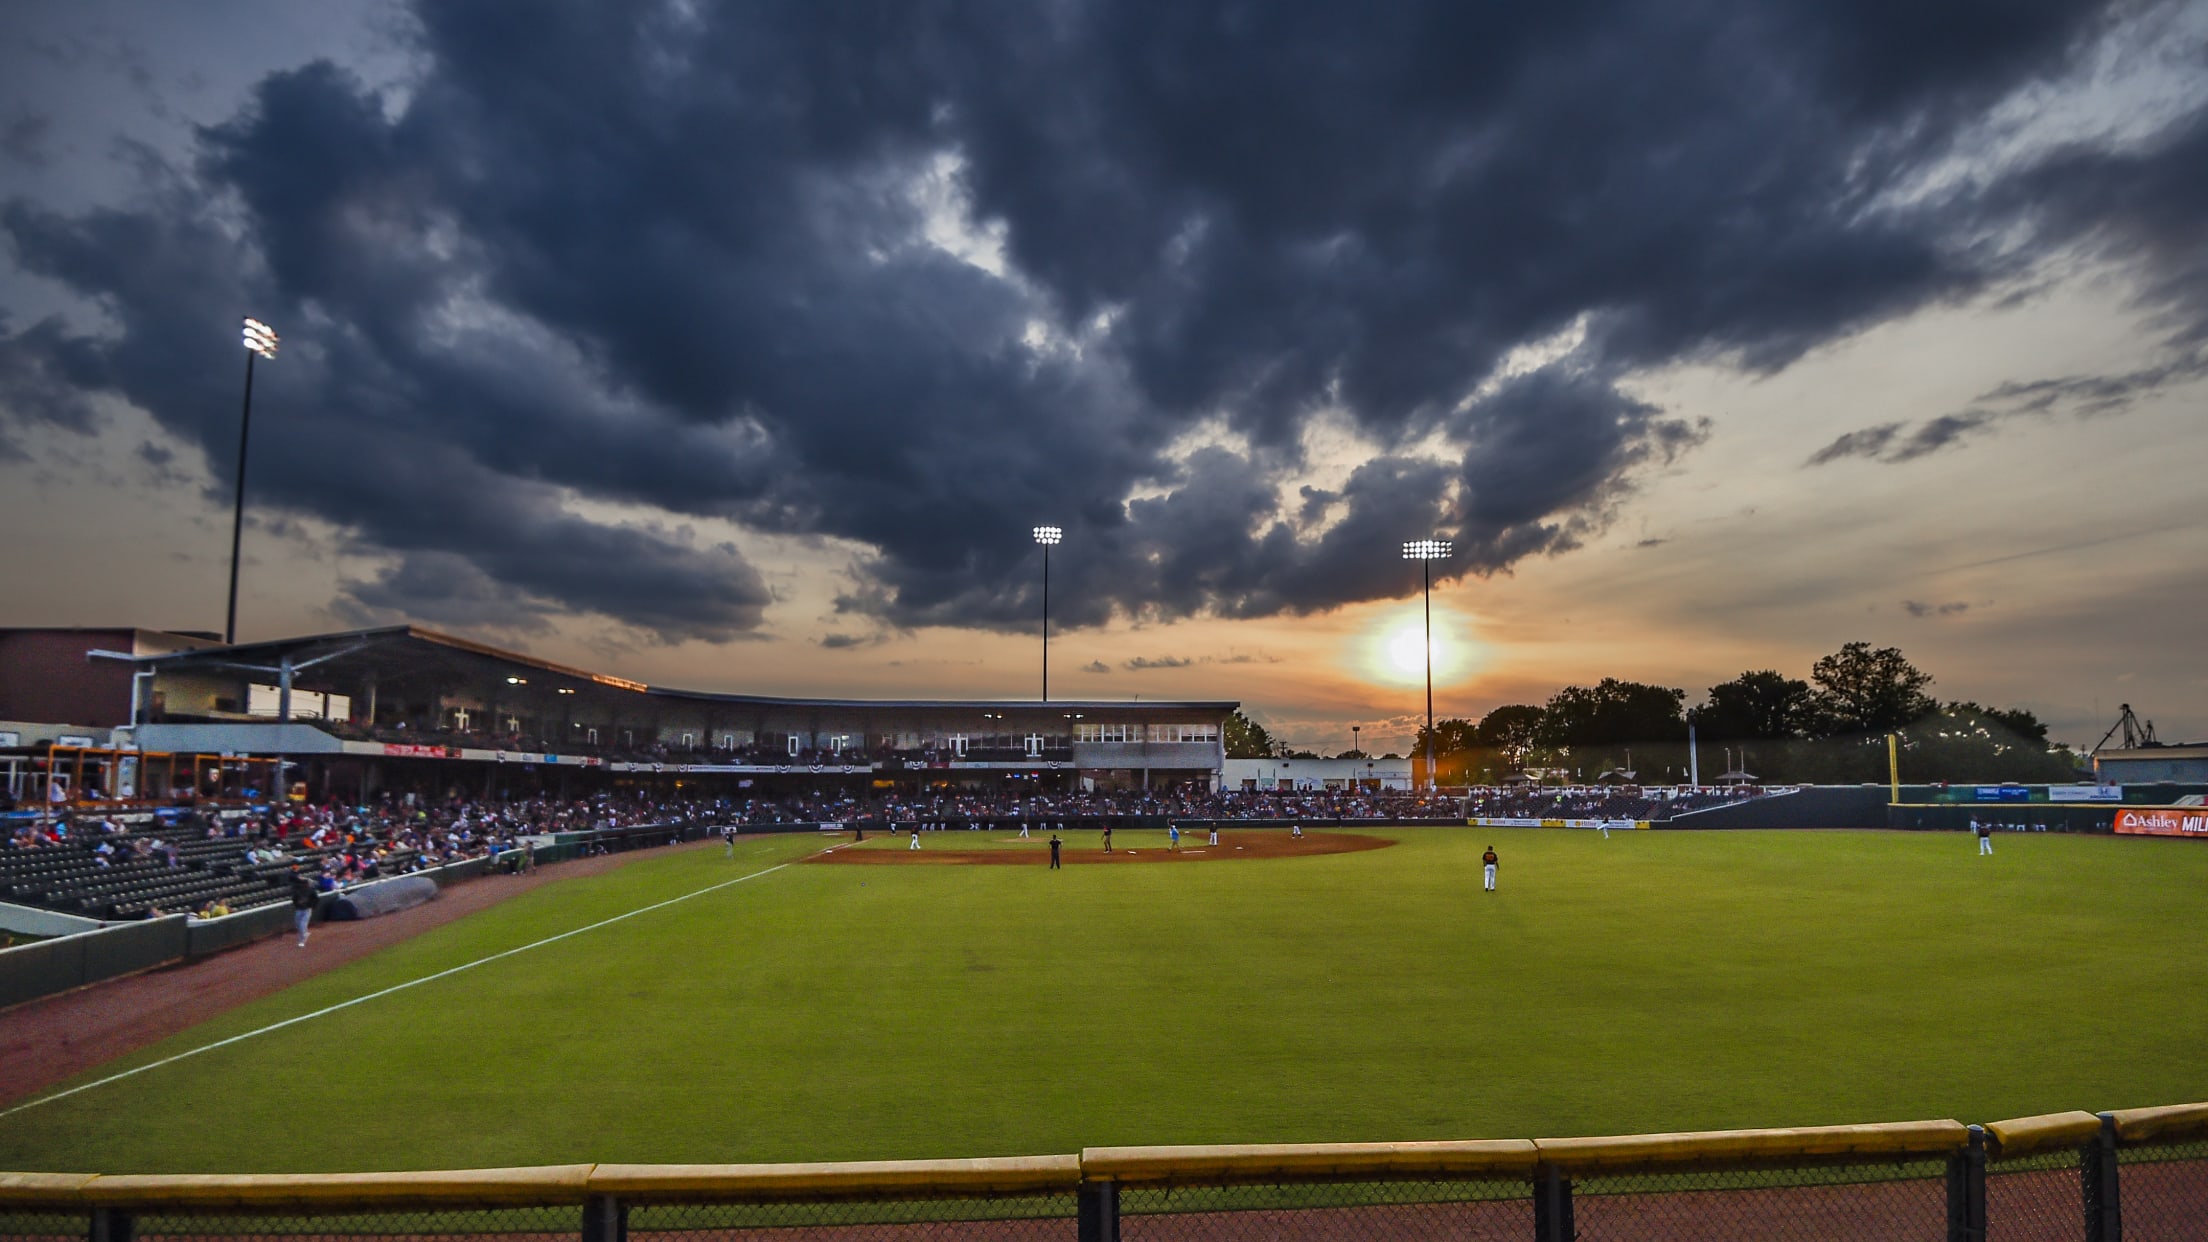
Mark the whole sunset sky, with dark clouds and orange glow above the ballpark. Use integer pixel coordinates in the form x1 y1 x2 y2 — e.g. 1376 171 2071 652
0 0 2208 751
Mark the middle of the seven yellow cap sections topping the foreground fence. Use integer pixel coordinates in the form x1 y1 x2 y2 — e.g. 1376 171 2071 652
1082 1138 1535 1185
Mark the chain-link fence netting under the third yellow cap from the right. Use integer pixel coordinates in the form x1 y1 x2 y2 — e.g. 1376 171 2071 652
1572 1160 1947 1242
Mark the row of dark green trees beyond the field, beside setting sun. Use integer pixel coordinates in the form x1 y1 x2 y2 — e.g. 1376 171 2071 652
1225 643 2080 785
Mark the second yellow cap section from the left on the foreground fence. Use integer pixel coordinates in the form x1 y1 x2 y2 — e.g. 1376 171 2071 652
79 1165 592 1211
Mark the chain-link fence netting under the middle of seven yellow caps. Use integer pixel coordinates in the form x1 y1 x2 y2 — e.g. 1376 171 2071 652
1119 1178 1532 1242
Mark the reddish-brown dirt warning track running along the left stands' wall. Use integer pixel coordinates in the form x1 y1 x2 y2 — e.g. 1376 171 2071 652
0 840 720 1105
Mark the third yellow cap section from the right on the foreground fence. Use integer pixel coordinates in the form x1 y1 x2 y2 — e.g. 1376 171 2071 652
1535 1120 1970 1171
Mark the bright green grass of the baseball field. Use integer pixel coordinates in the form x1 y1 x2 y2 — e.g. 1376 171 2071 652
0 829 2208 1171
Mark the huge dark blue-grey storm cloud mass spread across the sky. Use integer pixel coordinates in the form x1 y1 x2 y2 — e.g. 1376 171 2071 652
0 0 2197 639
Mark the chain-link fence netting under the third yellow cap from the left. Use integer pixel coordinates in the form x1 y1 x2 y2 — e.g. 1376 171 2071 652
629 1191 1075 1242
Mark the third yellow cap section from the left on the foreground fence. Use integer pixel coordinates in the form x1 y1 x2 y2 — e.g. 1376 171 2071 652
590 1156 1082 1200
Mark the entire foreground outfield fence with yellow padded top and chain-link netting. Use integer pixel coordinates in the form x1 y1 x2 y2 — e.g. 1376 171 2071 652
0 1103 2208 1242
